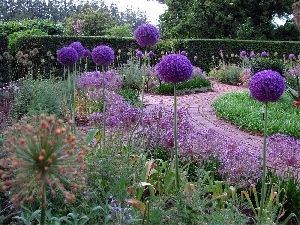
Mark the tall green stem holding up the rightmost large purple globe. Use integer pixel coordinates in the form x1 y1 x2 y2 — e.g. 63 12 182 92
259 102 268 217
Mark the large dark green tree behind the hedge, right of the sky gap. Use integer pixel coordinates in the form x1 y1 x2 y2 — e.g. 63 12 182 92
160 0 294 40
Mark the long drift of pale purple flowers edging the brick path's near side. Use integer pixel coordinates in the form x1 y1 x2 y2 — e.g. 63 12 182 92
137 106 261 186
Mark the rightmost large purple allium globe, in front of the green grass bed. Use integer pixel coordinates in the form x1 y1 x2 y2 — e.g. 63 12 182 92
249 70 285 102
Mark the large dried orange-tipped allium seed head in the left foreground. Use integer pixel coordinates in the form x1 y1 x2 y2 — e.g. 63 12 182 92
0 115 88 205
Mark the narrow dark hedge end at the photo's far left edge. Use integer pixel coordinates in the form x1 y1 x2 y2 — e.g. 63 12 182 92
0 34 9 84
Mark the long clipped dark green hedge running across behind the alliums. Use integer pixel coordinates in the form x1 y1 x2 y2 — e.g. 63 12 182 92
4 36 300 80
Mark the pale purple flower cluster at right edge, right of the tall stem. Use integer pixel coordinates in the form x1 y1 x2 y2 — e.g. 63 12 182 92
267 134 300 177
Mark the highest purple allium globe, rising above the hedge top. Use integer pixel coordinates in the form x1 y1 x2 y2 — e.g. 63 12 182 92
134 23 160 47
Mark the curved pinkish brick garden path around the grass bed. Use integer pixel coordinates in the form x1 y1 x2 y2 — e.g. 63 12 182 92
144 81 263 150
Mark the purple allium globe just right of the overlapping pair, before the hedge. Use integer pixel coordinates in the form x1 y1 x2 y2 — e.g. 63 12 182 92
92 45 115 66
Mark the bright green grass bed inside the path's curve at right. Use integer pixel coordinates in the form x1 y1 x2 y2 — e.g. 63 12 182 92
212 91 300 138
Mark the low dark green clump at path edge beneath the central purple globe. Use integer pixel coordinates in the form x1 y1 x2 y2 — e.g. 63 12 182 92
157 77 212 95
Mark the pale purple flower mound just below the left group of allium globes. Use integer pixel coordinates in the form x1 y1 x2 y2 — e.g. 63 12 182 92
77 70 122 91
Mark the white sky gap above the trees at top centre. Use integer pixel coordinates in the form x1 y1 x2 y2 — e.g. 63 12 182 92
104 0 167 25
